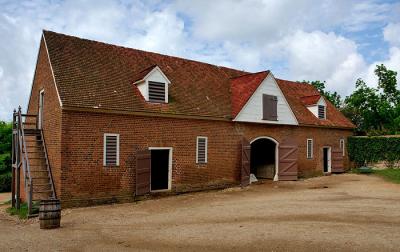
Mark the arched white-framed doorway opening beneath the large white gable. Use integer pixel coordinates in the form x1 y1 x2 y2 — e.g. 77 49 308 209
250 136 279 181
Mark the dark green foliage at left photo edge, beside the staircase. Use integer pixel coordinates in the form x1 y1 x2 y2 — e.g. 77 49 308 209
0 121 12 192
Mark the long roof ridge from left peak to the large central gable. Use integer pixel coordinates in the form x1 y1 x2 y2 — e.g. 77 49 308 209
43 29 246 72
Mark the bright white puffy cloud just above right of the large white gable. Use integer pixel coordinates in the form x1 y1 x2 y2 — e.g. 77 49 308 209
270 31 366 94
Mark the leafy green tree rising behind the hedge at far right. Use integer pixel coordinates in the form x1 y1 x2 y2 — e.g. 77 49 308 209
342 65 400 135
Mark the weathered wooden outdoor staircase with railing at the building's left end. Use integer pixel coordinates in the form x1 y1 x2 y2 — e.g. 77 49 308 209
12 108 56 217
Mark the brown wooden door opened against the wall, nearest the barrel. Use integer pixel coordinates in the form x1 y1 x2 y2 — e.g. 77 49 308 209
136 150 151 196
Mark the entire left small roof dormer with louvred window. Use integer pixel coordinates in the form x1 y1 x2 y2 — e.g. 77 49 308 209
133 65 171 103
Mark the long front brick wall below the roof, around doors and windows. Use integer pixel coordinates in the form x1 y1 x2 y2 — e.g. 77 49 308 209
61 111 351 206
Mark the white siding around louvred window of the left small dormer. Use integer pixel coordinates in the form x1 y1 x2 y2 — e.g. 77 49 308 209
134 66 171 103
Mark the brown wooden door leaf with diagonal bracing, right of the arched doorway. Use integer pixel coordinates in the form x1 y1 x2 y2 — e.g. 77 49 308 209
278 140 298 181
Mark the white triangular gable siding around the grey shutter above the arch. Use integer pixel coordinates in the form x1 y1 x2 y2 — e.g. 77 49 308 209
234 73 298 125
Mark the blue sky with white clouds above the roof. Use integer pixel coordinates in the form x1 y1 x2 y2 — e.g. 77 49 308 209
0 0 400 121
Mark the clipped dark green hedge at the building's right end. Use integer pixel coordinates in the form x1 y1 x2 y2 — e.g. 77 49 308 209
347 136 400 166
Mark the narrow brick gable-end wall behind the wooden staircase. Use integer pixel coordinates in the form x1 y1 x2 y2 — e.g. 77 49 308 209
27 39 61 199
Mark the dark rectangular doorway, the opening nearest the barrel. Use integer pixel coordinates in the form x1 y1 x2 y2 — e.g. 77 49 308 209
150 147 172 192
